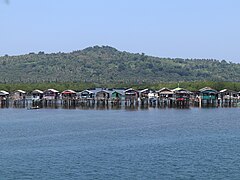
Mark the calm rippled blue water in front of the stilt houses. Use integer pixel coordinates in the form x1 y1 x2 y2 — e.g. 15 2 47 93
0 108 240 180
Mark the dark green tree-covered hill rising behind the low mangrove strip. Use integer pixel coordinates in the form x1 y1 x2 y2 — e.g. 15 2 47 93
0 46 240 84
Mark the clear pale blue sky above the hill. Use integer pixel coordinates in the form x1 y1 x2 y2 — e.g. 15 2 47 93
0 0 240 63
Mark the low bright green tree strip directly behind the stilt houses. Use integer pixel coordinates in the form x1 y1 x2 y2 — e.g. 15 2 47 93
0 81 240 92
